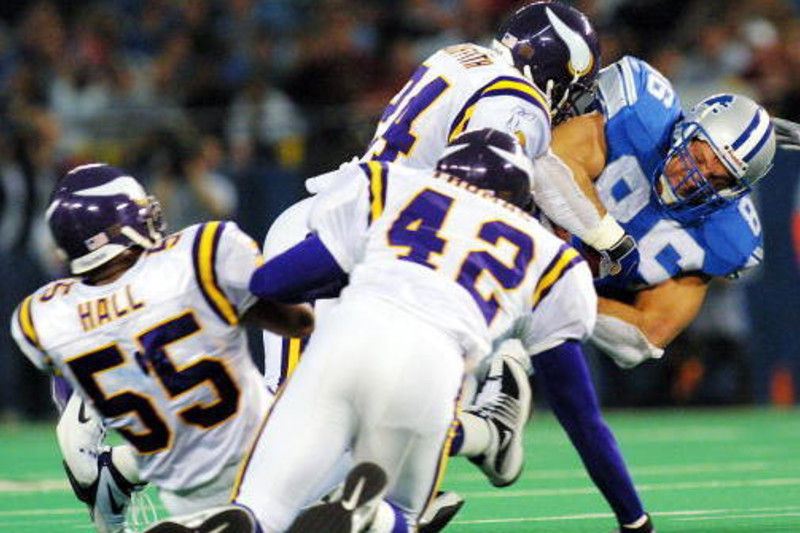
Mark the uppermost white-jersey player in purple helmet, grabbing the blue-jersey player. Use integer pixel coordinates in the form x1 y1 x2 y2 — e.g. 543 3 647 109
264 2 638 390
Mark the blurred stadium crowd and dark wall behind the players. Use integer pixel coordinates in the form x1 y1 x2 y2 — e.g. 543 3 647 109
0 0 800 419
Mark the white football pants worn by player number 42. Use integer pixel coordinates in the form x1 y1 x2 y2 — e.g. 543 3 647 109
235 293 464 533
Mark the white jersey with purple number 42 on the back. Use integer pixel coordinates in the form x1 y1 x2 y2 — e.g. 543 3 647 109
309 161 597 363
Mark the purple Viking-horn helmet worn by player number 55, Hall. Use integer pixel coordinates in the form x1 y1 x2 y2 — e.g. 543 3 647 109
46 163 165 274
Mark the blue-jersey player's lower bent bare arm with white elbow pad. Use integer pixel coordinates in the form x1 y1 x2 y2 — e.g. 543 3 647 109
591 276 708 368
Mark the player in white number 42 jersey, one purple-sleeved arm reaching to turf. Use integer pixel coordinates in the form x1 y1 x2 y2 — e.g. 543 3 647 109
153 130 649 533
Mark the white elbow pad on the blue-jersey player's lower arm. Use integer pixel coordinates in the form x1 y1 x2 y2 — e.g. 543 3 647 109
589 315 664 368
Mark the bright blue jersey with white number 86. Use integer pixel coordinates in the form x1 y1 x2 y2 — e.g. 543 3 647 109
596 57 763 288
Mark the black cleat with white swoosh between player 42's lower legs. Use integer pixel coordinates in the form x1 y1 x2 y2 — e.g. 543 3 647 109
286 463 388 533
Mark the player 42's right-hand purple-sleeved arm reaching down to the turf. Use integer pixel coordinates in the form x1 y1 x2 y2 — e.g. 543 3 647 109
531 341 645 529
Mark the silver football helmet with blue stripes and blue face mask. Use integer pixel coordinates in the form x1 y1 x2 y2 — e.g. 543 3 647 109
655 94 776 223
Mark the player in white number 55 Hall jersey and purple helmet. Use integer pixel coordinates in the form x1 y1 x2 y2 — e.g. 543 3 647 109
11 164 313 532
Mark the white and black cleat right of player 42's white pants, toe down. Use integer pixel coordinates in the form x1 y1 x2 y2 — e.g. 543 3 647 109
465 355 531 487
